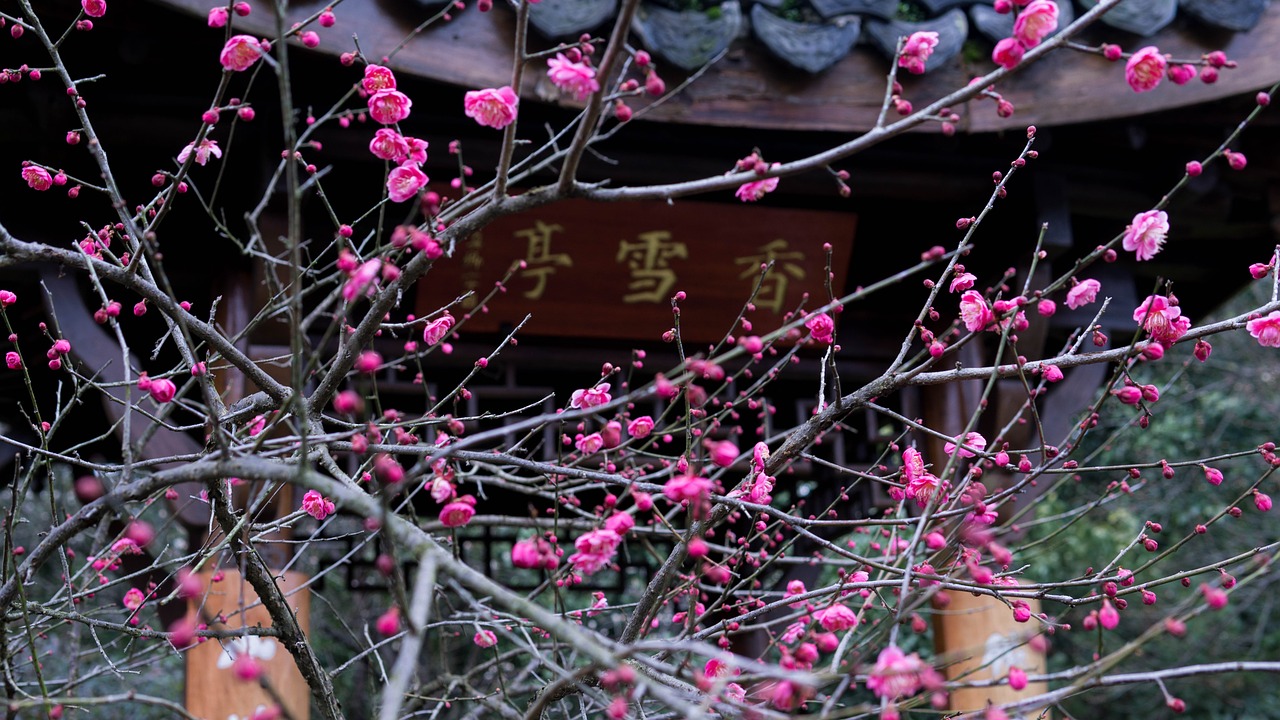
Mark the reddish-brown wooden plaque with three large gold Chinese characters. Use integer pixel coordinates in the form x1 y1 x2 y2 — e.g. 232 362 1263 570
417 200 855 342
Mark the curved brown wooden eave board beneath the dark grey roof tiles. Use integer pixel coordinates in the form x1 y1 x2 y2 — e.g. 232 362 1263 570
157 0 1280 132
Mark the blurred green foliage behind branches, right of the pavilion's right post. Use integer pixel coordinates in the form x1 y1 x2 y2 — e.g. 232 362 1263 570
1019 283 1280 719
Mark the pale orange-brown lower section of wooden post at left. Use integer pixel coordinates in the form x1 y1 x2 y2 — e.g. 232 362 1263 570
186 570 311 720
